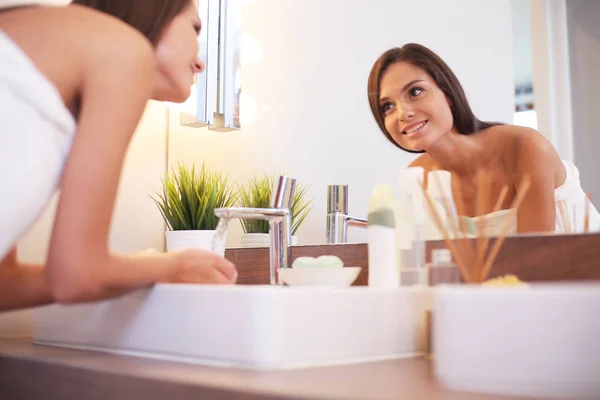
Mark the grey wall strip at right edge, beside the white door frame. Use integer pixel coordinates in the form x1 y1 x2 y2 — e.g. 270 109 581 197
566 0 600 202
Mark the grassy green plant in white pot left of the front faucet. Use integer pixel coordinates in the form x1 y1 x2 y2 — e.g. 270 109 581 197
151 163 237 255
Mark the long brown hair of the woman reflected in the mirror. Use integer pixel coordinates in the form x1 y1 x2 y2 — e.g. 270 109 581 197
367 43 500 153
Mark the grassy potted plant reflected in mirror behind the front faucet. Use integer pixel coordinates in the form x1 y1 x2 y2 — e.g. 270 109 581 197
238 174 314 247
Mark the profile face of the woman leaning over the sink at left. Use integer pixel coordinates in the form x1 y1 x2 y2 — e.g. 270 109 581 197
154 2 204 102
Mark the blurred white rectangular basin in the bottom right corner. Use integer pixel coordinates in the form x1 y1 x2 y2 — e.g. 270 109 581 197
433 283 600 399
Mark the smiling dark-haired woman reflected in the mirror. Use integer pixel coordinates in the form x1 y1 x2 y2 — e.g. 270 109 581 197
368 44 600 238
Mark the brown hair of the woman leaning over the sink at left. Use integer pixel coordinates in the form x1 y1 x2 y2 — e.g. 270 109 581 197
71 0 191 45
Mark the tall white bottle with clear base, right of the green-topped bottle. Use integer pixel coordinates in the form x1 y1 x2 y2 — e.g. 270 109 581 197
396 167 426 286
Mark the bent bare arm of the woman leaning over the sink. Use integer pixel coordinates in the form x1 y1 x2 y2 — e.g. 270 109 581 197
46 23 236 303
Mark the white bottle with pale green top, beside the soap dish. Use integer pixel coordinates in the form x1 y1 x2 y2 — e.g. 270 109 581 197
367 185 400 287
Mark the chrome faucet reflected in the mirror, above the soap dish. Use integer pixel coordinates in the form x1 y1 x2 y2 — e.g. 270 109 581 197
326 185 367 244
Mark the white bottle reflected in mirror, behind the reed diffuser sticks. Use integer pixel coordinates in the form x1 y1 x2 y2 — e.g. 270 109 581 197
425 170 458 240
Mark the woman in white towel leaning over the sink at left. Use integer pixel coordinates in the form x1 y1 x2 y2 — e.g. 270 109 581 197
0 0 237 311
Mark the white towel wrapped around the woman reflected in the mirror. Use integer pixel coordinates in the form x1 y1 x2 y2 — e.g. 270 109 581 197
468 160 600 236
